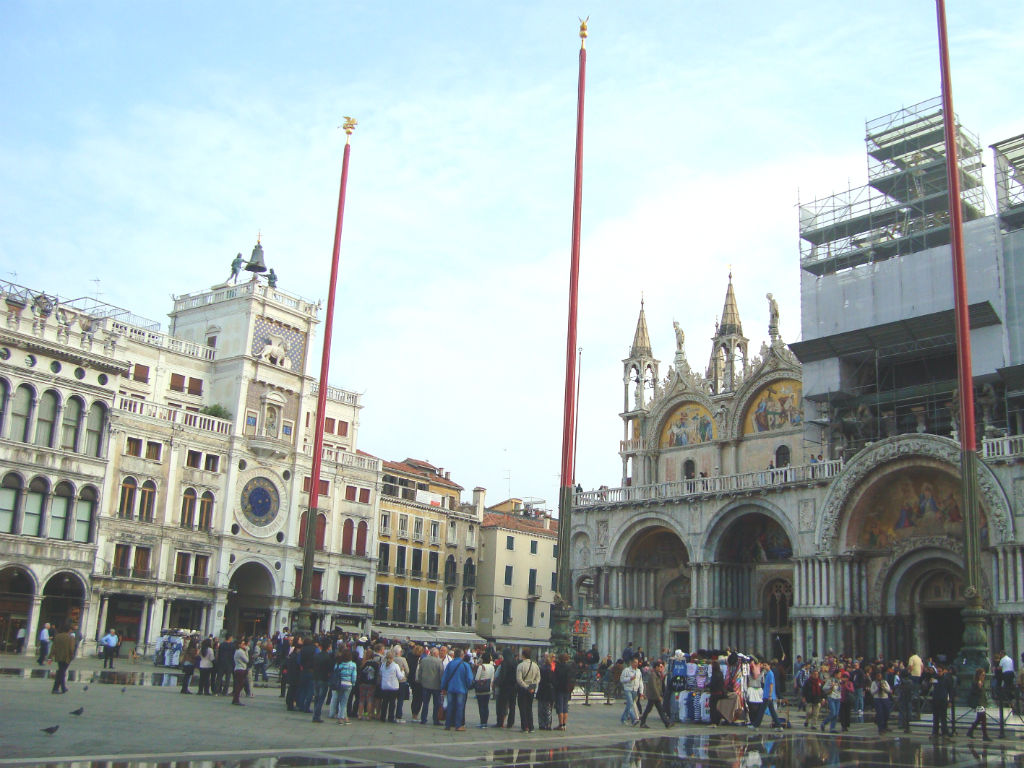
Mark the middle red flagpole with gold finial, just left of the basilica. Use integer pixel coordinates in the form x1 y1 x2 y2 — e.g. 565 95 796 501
551 19 587 651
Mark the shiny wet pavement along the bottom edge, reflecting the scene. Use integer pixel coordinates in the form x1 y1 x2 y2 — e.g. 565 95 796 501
22 732 1024 768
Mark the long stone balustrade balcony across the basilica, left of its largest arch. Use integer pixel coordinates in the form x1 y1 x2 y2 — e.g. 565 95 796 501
572 461 843 509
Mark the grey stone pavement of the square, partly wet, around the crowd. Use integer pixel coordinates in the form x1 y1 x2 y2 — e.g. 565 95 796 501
6 656 1024 768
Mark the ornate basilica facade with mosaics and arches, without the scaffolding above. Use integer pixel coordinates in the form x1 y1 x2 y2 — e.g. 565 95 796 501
571 275 1024 658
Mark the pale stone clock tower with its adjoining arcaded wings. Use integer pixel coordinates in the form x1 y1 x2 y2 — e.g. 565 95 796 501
0 244 381 648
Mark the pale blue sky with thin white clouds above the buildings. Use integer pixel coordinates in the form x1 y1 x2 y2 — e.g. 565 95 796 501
0 0 1024 509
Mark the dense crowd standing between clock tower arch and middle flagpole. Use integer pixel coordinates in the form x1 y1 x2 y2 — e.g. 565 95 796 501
176 630 575 732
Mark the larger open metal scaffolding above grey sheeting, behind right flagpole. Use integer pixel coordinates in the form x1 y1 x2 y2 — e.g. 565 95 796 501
800 97 983 275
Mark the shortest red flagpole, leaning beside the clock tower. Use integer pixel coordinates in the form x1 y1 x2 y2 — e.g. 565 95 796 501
297 117 356 632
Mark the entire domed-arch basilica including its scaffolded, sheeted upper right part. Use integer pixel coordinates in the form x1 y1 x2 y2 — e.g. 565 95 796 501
572 99 1024 657
